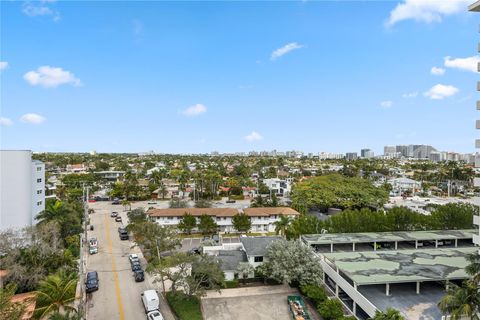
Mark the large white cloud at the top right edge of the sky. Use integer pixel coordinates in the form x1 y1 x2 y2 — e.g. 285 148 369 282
386 0 472 27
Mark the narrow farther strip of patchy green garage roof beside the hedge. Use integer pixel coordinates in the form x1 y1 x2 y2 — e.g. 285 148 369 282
302 229 478 245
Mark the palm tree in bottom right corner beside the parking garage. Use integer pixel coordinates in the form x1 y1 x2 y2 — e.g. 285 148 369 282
438 280 480 320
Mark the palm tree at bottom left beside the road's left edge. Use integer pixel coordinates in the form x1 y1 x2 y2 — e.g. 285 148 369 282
34 270 77 319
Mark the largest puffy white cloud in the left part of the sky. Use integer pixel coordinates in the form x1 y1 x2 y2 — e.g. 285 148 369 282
23 66 82 88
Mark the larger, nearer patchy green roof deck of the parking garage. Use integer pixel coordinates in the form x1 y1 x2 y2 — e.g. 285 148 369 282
323 247 478 285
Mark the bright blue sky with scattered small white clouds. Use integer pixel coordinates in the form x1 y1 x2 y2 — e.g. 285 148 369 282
0 0 480 153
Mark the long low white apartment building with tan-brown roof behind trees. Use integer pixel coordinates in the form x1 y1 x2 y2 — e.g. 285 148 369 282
147 207 300 233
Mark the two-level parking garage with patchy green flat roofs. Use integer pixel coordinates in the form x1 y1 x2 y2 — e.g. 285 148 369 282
301 229 478 319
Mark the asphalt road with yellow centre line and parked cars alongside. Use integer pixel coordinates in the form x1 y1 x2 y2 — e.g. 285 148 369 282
87 202 174 320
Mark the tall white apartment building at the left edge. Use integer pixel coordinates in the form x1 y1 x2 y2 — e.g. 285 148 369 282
0 150 45 230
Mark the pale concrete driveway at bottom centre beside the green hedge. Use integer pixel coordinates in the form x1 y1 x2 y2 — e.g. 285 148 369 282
202 286 298 320
